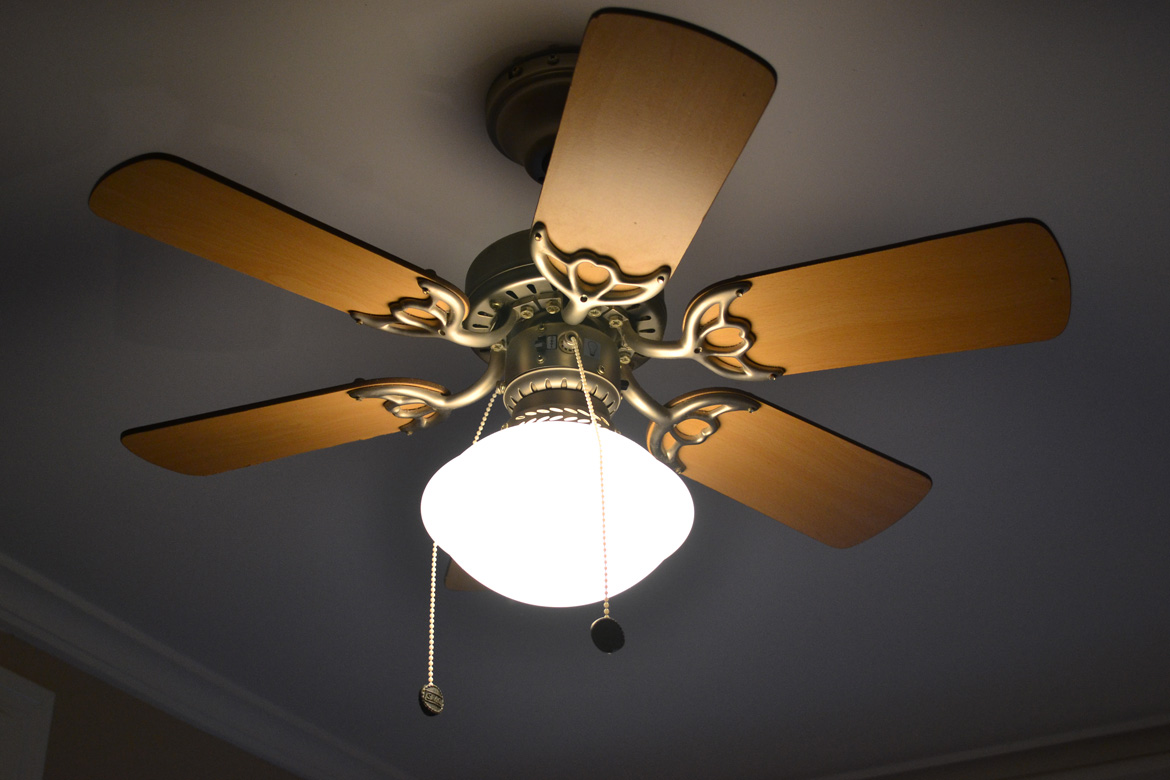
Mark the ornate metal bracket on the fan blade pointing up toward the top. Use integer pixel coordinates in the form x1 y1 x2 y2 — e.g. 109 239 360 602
530 222 670 325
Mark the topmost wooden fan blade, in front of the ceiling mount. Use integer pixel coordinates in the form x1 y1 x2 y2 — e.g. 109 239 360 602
536 11 776 276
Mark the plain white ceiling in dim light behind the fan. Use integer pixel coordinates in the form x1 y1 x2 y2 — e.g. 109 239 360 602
0 0 1170 780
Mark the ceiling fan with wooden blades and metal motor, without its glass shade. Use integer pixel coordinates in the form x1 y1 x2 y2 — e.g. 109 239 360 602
90 9 1069 603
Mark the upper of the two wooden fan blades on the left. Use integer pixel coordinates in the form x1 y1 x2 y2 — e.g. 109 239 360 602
89 154 463 313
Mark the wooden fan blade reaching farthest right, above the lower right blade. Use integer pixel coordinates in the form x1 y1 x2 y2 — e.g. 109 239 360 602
730 221 1071 374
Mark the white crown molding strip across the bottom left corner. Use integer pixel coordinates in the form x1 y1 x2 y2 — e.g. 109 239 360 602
0 553 413 780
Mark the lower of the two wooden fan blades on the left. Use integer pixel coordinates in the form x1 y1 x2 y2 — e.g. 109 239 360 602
122 379 447 476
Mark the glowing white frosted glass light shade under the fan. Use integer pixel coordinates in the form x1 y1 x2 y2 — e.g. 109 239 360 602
421 421 695 607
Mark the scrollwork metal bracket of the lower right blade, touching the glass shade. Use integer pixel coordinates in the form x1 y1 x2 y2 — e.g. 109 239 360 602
621 370 759 474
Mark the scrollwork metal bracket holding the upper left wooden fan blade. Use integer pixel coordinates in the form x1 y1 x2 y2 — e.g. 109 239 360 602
350 278 517 350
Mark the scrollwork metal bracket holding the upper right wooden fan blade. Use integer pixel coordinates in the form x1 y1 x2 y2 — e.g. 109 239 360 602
611 282 784 380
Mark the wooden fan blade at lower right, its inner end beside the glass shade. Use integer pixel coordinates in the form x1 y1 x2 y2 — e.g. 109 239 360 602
667 391 930 547
